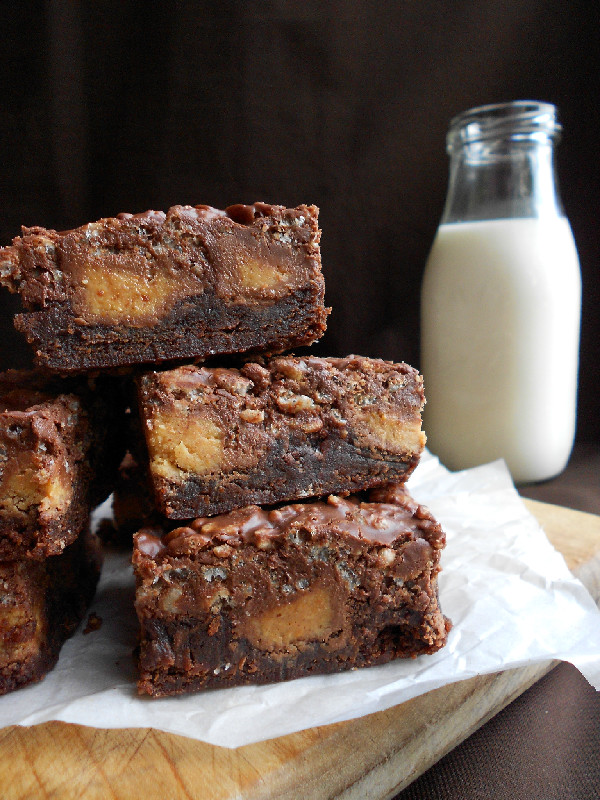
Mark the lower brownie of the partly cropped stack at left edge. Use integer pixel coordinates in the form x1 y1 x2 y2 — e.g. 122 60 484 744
0 530 101 694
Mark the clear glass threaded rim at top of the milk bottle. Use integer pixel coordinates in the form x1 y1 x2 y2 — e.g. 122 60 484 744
446 100 562 153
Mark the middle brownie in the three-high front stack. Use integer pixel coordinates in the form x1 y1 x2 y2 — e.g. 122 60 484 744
139 356 425 519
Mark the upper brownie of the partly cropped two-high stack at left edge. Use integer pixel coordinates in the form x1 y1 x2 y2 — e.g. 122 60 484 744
0 370 124 561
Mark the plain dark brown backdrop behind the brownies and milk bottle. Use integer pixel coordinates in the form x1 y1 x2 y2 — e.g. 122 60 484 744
0 0 600 441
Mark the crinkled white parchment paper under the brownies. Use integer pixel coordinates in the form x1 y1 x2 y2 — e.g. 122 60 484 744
0 453 600 747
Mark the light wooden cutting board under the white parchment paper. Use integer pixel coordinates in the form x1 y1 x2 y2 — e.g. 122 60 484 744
0 500 600 800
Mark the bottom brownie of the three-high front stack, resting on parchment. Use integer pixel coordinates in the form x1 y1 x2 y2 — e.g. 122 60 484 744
133 485 450 696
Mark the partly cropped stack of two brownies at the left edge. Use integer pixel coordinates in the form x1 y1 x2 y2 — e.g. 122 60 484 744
0 371 120 694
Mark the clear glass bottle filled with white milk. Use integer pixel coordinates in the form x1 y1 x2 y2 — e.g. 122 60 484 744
421 101 581 483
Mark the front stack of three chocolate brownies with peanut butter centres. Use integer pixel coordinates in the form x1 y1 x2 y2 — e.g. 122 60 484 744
0 203 449 696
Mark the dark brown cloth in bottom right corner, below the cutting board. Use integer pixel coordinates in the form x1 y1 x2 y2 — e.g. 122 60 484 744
395 664 600 800
